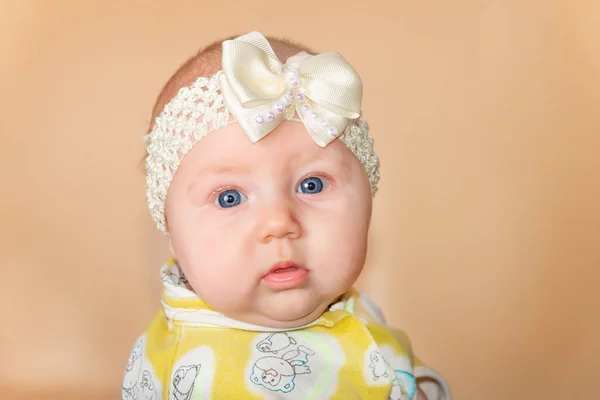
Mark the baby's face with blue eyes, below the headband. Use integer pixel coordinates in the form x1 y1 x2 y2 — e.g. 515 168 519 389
166 121 372 328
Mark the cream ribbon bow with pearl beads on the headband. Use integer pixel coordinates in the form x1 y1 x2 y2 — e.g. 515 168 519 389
220 32 362 147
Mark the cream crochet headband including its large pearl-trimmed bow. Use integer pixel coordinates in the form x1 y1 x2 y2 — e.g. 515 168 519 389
146 32 379 234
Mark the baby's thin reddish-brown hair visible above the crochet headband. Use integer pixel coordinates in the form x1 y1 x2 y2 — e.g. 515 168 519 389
148 35 315 132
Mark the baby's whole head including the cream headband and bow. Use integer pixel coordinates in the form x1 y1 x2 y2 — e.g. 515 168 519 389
147 32 379 328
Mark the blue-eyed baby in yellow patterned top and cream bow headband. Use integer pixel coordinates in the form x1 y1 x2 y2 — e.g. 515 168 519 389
121 32 450 400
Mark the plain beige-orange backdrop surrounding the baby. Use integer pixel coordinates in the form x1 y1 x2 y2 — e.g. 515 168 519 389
0 0 600 400
